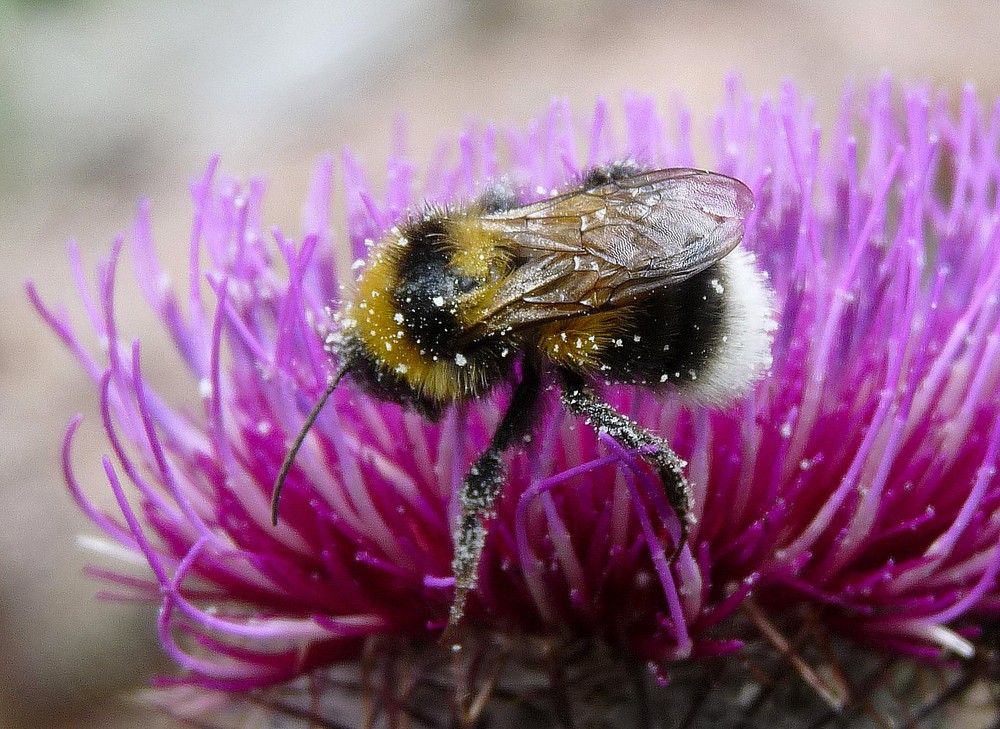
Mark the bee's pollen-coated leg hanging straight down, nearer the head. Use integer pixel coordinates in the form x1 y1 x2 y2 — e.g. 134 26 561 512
441 363 541 643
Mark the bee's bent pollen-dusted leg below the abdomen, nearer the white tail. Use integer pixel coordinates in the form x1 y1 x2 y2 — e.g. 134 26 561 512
560 370 691 562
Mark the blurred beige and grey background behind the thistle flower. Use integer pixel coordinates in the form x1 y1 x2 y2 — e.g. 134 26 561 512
0 0 1000 728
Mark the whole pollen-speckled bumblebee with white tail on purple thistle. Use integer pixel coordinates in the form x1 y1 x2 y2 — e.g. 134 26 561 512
272 162 773 632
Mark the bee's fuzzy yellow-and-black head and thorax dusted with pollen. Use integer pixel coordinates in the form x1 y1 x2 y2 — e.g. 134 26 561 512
328 211 516 419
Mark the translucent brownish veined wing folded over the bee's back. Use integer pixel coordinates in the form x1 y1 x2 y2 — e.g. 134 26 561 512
473 168 753 330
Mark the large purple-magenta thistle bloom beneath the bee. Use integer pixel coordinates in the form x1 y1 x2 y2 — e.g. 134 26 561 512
29 80 1000 719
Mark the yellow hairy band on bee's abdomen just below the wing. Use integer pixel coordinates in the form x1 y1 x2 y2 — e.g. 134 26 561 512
538 309 629 372
